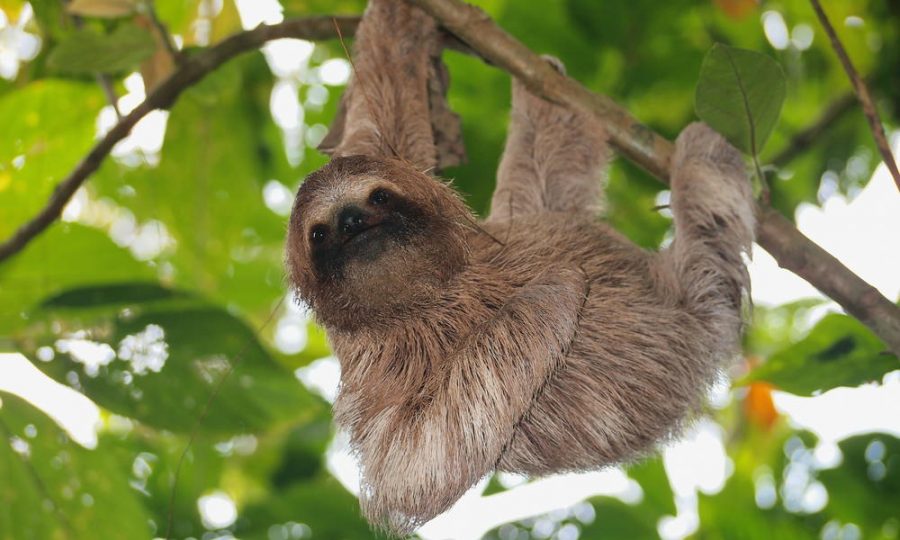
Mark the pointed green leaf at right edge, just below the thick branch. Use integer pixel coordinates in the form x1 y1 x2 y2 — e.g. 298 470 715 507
745 313 900 395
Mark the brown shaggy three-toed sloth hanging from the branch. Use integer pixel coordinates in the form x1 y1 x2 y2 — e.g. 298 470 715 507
287 0 754 534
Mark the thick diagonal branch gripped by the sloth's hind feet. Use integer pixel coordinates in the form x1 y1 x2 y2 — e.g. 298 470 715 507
408 0 900 354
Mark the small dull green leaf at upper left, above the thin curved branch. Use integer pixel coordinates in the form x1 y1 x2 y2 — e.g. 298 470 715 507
47 24 156 75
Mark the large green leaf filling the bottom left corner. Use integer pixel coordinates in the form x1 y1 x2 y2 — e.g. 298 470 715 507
0 392 152 540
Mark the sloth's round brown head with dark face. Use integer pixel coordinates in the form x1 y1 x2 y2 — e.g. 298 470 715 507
286 156 474 330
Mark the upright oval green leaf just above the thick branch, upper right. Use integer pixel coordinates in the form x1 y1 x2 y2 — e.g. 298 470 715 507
694 43 785 156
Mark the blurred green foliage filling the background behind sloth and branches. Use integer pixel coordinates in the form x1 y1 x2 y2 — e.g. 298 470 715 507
0 0 900 540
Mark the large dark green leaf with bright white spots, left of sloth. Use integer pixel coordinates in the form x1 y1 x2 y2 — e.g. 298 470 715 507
19 283 324 435
